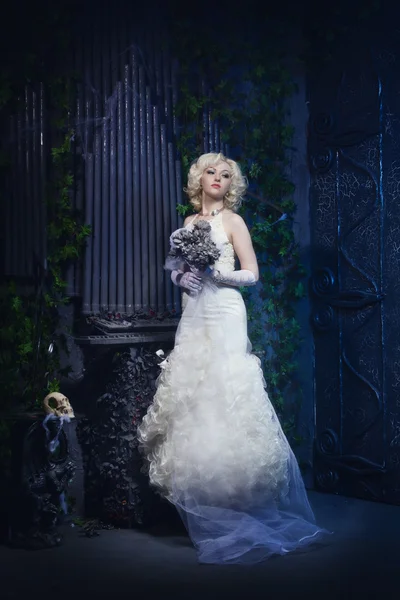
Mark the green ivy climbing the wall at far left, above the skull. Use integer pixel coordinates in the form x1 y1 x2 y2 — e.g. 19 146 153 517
0 11 91 418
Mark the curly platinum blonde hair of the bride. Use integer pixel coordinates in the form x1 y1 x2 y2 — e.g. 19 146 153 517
184 152 247 212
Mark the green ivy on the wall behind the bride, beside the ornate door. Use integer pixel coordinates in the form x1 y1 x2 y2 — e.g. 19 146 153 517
171 20 305 441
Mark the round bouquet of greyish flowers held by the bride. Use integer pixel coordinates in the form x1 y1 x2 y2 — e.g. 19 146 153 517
165 221 221 272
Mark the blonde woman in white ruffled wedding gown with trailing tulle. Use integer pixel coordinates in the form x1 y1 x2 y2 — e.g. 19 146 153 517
138 153 324 563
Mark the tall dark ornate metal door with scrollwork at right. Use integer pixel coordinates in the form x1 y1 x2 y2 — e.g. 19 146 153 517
308 26 400 504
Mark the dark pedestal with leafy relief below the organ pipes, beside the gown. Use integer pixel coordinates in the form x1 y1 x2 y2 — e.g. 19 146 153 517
77 345 168 527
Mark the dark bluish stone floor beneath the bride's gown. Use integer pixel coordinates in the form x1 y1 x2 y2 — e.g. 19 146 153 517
0 492 400 600
